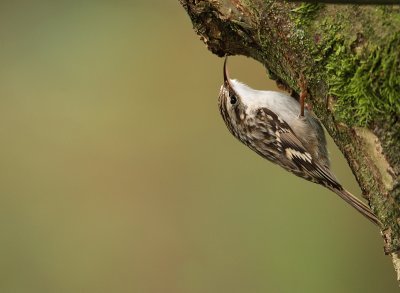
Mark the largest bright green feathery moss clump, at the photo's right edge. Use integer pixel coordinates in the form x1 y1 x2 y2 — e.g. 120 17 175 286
326 34 400 125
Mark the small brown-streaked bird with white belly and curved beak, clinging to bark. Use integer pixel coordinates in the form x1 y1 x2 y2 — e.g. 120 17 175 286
218 56 382 227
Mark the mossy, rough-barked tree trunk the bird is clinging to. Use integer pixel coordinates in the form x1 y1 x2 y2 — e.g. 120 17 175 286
180 0 400 278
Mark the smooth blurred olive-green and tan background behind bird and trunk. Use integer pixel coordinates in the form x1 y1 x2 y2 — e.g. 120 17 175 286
0 0 397 293
